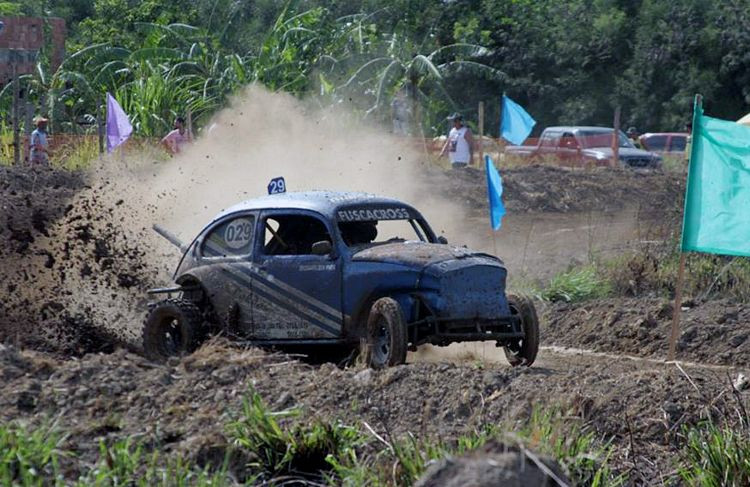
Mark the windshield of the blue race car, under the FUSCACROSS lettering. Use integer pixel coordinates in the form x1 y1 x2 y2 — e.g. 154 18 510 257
339 218 429 247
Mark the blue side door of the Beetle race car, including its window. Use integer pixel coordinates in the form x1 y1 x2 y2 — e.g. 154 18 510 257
253 210 343 341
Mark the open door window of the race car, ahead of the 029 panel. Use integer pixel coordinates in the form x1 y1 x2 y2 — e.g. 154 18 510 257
263 215 333 255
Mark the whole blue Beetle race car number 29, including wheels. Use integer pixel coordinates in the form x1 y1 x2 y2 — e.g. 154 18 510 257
143 191 539 368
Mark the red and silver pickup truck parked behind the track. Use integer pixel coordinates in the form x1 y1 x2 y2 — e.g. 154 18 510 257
505 127 662 168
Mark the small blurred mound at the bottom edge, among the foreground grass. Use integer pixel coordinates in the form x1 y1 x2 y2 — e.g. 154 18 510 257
415 441 570 487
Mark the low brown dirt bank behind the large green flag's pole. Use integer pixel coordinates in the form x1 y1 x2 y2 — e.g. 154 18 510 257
542 298 750 366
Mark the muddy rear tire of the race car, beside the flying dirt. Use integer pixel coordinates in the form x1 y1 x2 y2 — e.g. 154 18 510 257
143 299 203 362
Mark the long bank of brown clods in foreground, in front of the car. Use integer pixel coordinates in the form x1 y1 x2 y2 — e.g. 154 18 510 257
0 342 732 483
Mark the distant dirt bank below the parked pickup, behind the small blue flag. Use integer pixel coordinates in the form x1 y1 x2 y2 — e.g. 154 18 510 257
428 165 685 213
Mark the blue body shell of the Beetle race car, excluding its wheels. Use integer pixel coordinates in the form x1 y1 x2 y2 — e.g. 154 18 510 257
169 192 523 349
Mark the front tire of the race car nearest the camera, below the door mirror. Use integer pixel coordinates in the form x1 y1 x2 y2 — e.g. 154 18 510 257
360 298 408 369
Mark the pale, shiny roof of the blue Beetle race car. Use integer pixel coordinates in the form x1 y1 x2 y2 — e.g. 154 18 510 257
211 191 419 222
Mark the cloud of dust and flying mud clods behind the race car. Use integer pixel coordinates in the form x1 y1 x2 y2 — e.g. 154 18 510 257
1 87 476 356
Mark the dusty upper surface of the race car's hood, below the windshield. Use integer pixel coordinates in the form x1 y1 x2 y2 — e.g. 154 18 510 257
352 242 502 269
